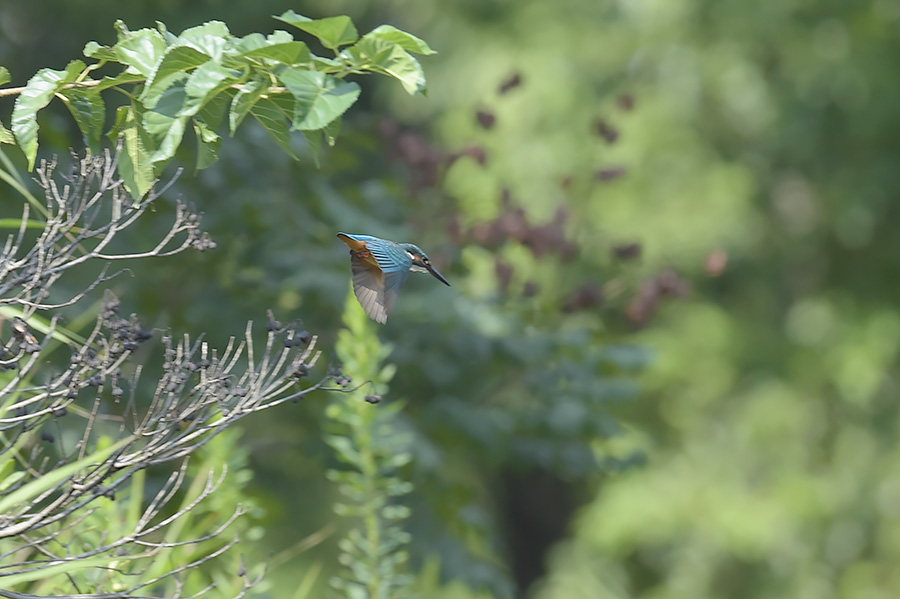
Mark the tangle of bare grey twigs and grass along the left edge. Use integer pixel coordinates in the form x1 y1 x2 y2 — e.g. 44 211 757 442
0 152 345 599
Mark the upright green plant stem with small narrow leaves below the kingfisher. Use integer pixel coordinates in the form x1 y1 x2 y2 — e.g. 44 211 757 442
326 291 412 599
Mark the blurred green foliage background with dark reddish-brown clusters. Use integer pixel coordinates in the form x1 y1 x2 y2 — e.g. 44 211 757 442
0 0 900 599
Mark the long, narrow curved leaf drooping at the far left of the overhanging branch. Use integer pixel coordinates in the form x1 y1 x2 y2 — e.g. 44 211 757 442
12 60 84 171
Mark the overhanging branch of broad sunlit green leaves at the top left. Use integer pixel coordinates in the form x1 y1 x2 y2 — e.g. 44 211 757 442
0 10 434 199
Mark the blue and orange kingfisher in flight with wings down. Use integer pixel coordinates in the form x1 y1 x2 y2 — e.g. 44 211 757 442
338 233 450 324
